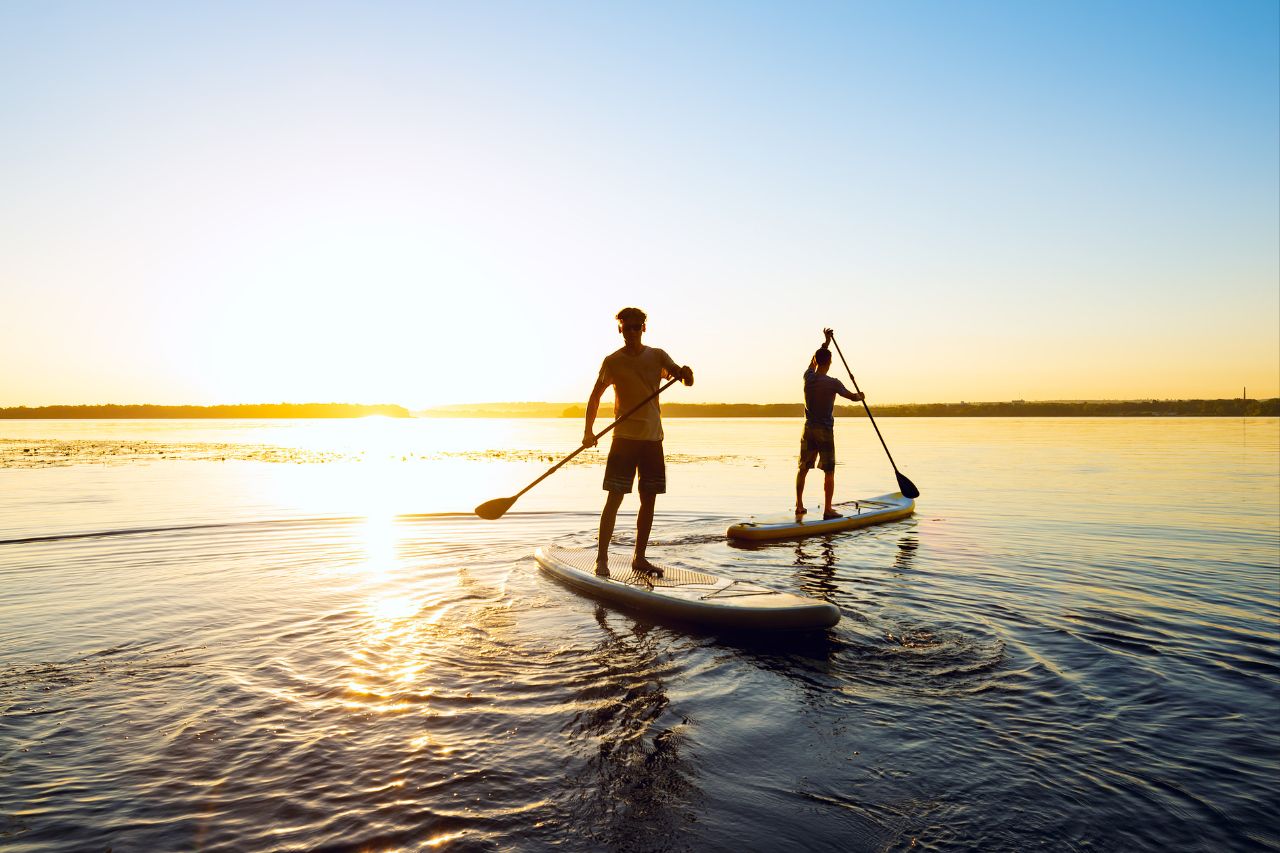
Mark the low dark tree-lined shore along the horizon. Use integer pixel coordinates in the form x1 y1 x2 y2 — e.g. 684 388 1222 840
0 397 1280 420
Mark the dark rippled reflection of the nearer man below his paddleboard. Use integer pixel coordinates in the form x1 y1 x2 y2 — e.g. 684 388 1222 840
563 606 704 850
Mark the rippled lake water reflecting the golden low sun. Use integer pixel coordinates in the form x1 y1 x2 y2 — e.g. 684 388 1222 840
0 419 1280 850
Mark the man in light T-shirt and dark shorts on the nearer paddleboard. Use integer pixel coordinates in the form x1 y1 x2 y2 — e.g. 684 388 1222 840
582 307 694 575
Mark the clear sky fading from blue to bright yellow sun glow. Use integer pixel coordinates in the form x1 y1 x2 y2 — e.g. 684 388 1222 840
0 0 1280 406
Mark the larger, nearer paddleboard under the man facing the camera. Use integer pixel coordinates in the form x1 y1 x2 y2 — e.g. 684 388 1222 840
534 546 840 630
